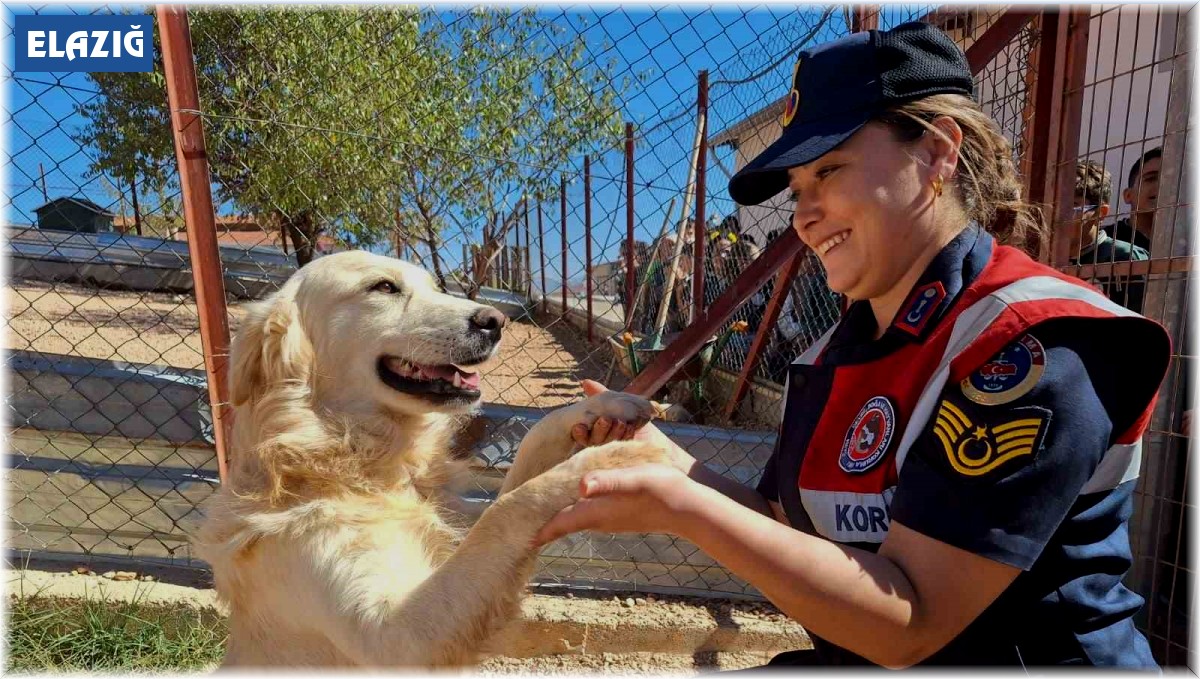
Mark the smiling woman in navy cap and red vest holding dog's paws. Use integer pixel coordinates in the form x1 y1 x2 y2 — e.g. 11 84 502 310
539 23 1170 668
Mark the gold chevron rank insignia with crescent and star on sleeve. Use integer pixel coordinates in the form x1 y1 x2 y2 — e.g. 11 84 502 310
934 399 1050 477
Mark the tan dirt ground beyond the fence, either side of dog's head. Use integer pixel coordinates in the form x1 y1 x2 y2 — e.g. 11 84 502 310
5 281 624 407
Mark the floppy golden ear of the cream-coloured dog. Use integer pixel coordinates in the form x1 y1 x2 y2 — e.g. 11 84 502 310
229 295 312 405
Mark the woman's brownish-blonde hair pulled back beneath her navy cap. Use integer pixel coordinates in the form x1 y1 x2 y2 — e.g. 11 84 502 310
878 95 1048 258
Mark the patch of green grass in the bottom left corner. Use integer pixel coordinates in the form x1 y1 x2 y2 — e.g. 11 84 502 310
5 595 226 672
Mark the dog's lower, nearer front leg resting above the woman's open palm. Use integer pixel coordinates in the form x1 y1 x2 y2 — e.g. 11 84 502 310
324 441 668 668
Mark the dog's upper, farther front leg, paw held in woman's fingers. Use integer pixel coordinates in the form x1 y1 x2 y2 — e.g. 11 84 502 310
499 391 654 495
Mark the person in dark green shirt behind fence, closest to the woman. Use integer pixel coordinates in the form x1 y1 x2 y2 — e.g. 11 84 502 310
1066 160 1150 313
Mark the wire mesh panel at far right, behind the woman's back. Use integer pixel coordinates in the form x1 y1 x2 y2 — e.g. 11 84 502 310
1057 5 1196 668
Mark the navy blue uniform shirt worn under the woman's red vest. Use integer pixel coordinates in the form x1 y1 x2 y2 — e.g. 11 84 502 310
758 227 1170 669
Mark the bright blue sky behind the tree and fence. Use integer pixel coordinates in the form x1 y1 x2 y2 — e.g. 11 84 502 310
2 5 931 280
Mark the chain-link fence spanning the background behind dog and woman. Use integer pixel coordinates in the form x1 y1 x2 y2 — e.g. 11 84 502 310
5 5 1192 662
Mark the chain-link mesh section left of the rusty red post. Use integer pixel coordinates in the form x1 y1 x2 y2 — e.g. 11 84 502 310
4 7 217 575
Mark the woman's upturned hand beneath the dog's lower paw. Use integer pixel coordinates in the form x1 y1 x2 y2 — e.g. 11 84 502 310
534 464 700 547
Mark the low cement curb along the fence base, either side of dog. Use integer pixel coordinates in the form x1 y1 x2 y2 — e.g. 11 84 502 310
5 569 811 657
